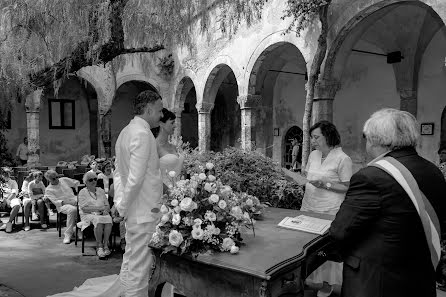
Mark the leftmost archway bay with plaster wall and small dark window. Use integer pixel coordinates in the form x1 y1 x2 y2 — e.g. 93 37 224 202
39 78 98 165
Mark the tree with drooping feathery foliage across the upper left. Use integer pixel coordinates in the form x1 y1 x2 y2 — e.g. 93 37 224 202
0 0 265 95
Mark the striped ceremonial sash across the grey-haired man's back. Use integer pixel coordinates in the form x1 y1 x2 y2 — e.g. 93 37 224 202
370 157 441 269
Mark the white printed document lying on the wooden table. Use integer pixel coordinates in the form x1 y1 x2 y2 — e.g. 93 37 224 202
278 215 331 235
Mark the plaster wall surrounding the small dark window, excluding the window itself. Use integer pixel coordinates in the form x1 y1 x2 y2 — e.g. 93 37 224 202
40 80 91 166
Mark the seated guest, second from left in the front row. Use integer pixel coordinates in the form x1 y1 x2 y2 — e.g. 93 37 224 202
27 171 49 231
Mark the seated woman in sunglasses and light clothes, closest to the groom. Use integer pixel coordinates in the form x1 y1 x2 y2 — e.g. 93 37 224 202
78 171 113 258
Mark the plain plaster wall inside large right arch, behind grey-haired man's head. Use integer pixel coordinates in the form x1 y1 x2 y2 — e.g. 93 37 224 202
333 41 400 170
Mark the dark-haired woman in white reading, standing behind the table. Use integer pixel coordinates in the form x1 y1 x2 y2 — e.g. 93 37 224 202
284 121 352 297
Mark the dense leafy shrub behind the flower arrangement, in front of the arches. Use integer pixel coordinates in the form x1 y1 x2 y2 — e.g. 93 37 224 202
183 145 304 209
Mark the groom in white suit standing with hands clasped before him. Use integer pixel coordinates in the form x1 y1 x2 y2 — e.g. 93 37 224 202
113 90 163 297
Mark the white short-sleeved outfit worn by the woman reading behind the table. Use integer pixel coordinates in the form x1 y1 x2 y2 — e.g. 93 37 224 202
301 147 352 215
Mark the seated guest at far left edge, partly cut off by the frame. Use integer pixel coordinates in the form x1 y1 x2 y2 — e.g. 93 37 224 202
0 167 21 233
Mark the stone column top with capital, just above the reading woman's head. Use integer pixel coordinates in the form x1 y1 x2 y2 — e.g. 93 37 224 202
312 79 341 124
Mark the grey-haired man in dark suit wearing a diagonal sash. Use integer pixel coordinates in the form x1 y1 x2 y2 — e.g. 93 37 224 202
329 109 446 297
